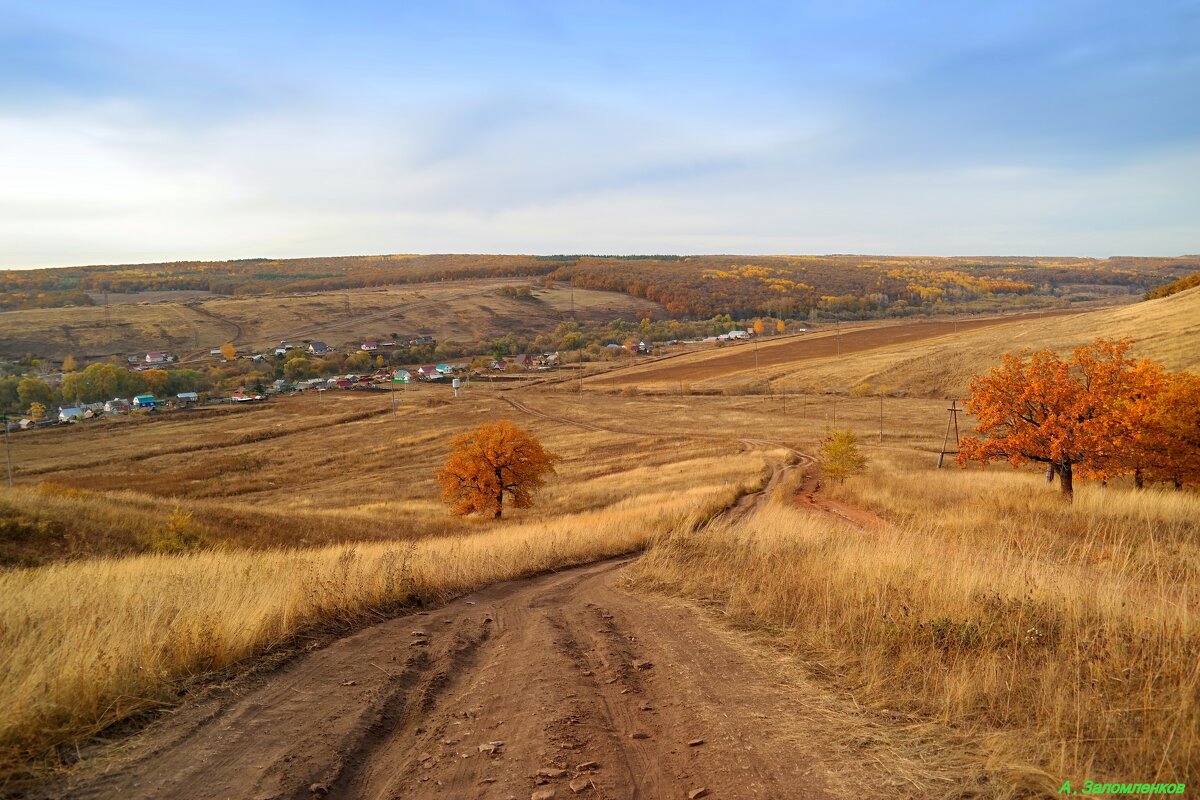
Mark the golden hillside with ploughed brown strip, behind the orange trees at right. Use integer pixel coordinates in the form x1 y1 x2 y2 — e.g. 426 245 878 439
593 289 1200 397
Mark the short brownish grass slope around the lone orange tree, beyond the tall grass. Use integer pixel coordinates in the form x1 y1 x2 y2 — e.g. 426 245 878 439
0 387 764 566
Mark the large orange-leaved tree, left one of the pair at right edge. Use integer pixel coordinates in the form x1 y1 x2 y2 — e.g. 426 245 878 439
958 339 1154 500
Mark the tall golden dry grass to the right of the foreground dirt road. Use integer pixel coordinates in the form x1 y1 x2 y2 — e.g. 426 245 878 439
637 470 1200 796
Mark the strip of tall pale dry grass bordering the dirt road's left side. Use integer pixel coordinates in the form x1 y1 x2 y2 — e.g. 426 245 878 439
0 473 763 770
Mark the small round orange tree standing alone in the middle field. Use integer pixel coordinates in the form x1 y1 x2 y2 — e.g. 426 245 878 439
438 420 559 519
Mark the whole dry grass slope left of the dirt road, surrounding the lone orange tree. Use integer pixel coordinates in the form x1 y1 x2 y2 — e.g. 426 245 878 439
0 396 766 770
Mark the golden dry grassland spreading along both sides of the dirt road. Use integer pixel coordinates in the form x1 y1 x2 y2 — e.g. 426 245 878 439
0 291 1200 798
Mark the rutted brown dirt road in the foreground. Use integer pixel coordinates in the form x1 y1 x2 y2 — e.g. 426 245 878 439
58 560 839 800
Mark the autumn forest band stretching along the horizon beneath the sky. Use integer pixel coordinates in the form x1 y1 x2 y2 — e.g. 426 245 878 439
0 255 1200 319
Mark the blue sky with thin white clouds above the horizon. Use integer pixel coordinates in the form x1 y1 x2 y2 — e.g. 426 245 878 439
0 0 1200 269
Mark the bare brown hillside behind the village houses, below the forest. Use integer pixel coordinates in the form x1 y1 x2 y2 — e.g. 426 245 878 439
0 278 665 359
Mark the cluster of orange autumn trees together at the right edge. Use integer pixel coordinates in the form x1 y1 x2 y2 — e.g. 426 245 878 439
958 338 1200 498
